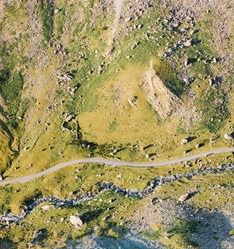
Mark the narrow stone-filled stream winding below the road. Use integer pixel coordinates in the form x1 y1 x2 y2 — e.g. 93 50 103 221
0 164 234 228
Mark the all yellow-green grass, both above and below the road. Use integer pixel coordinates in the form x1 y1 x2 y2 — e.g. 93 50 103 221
0 0 233 248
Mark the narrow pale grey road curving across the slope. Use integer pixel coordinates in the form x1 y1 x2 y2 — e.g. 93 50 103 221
0 147 234 186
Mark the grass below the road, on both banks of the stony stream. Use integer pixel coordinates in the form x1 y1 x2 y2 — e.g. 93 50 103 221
0 154 232 248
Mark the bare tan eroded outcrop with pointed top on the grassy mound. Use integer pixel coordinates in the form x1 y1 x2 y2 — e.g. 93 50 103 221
141 63 182 119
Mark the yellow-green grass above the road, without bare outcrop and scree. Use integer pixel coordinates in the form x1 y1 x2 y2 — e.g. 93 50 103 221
1 1 231 176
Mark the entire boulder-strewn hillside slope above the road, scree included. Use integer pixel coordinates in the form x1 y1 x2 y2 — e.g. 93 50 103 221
1 1 232 174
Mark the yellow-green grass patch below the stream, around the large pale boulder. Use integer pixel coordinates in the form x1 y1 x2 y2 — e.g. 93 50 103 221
0 192 136 248
